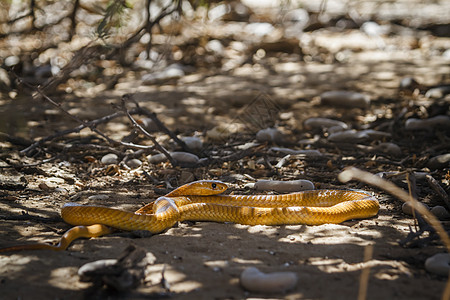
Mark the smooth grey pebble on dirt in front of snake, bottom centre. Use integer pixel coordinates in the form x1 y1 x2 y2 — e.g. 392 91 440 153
240 267 298 293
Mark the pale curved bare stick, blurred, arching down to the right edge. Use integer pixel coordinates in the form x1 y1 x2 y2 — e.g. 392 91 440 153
338 167 450 252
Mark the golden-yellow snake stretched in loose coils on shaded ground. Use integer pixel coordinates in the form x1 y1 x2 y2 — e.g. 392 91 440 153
0 180 379 252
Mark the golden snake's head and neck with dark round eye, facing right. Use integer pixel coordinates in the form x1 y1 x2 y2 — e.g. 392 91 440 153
166 180 228 197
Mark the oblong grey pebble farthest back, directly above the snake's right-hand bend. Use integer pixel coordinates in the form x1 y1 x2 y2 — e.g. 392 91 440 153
320 91 370 108
